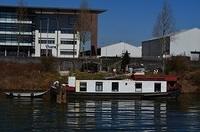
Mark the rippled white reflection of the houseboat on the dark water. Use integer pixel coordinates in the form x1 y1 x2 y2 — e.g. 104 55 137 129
67 100 167 130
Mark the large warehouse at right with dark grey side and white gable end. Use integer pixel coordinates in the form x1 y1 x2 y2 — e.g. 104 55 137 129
142 28 200 59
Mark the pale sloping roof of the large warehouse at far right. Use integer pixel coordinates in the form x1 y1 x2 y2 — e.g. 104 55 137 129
143 28 200 42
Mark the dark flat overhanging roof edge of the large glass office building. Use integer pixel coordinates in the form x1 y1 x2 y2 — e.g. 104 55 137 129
0 5 106 14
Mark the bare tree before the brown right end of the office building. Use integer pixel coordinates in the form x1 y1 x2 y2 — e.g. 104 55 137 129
76 0 93 56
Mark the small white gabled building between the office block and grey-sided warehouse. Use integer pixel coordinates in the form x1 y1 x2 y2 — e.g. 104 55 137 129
100 42 142 58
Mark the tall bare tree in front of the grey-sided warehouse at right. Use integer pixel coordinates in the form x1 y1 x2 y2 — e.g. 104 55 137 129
153 0 175 72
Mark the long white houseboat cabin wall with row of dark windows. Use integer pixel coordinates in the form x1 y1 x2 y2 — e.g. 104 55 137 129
76 80 167 93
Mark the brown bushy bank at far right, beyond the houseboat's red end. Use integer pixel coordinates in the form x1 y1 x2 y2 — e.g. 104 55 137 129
166 56 200 93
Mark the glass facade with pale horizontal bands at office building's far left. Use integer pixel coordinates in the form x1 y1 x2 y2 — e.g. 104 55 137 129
0 12 33 44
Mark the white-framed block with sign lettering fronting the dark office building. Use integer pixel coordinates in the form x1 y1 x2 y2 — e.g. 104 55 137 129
33 30 80 58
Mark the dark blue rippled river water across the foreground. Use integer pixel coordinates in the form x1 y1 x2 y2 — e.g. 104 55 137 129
0 95 200 132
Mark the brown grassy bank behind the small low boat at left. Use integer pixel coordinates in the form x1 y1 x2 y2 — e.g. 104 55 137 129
0 62 59 91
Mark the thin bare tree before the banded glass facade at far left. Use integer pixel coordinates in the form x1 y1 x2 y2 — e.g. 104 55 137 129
17 0 27 56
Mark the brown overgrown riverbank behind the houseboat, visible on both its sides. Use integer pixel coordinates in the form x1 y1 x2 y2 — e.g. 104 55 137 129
0 59 200 93
